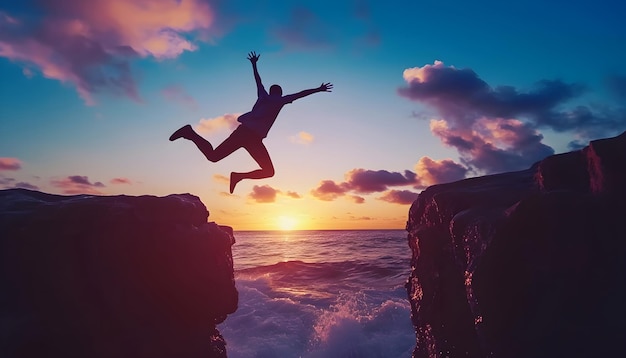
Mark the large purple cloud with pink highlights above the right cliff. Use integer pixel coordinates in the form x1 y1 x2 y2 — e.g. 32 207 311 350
398 61 560 173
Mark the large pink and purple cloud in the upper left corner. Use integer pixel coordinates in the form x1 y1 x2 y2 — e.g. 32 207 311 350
0 0 215 105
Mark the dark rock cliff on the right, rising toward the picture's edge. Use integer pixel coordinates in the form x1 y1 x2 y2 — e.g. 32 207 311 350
407 133 626 358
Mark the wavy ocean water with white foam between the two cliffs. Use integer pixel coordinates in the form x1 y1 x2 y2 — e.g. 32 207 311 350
218 230 415 358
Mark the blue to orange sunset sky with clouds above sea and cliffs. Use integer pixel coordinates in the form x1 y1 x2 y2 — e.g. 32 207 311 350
0 0 626 230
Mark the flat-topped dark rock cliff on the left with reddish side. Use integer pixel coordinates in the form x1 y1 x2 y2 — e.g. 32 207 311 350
0 189 238 358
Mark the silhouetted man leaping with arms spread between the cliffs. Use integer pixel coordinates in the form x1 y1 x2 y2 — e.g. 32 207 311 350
170 51 333 194
